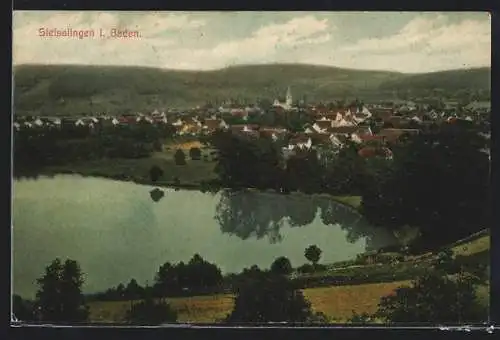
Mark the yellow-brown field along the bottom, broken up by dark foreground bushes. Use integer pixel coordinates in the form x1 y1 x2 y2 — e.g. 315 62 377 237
89 281 489 323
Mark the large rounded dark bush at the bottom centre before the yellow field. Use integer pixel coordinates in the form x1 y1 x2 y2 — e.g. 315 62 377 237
226 272 313 322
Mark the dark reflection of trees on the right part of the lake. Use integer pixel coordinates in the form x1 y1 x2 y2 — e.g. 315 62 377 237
215 191 395 249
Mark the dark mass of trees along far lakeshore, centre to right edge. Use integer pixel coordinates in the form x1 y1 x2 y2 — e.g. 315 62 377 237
209 120 491 247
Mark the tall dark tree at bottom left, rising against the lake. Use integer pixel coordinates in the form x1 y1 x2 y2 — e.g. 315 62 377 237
36 258 88 322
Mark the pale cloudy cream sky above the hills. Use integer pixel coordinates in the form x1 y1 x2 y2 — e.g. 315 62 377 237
12 11 491 73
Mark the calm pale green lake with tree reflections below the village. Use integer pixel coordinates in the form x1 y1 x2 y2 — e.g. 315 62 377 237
12 175 394 297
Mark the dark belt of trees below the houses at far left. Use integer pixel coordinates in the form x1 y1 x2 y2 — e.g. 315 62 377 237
14 123 175 177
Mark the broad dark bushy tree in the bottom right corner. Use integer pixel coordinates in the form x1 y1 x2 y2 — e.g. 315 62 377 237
375 273 488 324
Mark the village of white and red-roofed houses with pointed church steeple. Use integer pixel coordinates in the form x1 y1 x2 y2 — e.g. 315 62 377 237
13 87 491 164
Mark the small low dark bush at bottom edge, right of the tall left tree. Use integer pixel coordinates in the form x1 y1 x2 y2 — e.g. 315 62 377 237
126 294 177 325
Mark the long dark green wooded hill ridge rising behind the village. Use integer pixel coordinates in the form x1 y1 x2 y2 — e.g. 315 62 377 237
14 64 489 114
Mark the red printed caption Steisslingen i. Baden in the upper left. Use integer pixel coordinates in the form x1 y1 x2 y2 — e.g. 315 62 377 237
38 27 142 39
